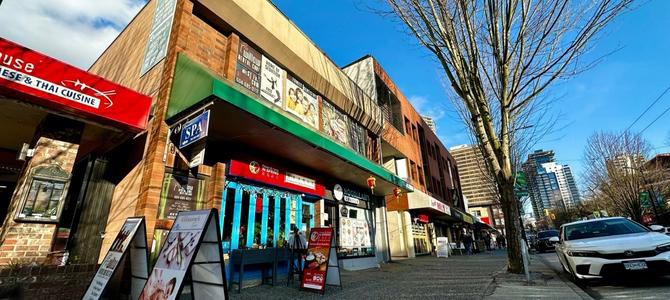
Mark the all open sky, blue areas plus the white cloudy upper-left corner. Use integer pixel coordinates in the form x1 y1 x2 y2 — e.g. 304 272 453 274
0 0 670 185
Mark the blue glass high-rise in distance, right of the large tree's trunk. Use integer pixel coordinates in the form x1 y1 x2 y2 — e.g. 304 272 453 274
523 150 580 219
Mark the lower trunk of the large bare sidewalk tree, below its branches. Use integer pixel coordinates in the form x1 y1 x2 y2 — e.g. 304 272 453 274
498 176 524 273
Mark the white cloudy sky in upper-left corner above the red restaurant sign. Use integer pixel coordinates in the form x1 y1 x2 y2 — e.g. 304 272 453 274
0 0 145 69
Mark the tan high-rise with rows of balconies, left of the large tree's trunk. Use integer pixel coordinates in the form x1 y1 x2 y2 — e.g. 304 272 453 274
449 145 505 230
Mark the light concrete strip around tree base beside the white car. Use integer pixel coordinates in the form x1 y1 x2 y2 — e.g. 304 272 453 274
485 255 593 300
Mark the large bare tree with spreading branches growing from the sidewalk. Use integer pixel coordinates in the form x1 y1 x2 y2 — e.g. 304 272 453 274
386 0 631 273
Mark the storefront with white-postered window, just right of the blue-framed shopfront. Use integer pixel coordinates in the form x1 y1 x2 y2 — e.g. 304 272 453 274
317 183 386 270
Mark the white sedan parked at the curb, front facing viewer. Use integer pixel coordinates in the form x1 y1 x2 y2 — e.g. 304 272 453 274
556 217 670 282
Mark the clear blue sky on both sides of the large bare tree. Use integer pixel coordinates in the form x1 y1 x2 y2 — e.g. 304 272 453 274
274 0 670 183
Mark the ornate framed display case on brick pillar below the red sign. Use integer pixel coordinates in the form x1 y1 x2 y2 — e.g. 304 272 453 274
17 165 70 222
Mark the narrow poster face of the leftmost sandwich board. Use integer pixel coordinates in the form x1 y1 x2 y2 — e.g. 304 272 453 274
82 218 146 300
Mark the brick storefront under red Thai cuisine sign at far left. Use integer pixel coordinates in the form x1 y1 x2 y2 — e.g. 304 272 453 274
0 38 151 264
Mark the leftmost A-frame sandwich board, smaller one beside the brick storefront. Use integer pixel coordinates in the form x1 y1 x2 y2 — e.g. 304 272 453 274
82 217 149 300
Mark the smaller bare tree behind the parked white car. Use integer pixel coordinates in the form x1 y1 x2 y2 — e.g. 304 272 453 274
584 131 651 221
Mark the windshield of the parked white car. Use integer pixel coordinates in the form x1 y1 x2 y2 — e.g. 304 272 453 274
565 219 649 241
